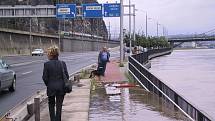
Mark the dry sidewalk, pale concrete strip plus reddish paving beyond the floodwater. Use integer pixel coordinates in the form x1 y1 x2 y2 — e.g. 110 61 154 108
29 60 126 121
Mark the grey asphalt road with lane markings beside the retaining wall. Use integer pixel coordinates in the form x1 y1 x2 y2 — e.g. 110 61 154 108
0 51 119 117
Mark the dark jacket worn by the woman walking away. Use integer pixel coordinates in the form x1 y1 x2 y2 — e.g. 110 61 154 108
42 59 69 96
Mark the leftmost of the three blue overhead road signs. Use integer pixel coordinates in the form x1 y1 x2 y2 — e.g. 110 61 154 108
56 4 76 19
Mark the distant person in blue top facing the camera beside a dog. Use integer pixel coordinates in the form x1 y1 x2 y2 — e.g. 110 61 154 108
97 47 110 76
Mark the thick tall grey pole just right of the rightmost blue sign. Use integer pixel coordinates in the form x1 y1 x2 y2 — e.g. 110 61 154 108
120 0 124 64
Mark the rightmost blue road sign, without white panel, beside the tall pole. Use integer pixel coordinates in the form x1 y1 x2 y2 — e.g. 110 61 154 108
104 3 121 17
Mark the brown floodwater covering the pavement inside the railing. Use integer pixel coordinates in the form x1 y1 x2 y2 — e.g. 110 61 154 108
89 87 190 121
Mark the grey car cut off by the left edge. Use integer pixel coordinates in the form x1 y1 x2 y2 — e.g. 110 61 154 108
0 59 16 92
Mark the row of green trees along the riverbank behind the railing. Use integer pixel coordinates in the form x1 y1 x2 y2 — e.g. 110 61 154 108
124 34 170 48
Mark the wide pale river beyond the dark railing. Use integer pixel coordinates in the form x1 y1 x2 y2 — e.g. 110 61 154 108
150 49 215 120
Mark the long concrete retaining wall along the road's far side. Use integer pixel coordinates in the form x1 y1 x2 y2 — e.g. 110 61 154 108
0 29 119 56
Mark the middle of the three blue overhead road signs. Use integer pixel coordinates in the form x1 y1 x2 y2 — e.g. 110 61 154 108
82 3 103 18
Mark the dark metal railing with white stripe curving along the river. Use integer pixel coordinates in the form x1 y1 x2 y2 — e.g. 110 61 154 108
128 50 211 121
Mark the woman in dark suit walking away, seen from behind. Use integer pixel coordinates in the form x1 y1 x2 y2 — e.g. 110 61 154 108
42 46 69 121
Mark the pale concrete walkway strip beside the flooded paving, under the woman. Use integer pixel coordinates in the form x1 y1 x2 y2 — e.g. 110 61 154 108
29 79 90 121
